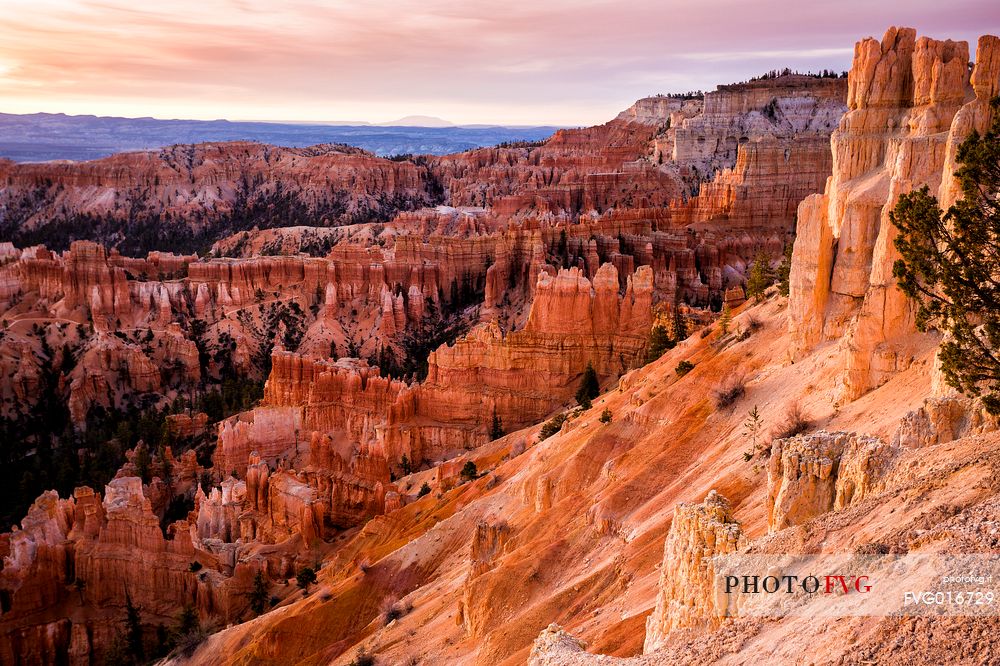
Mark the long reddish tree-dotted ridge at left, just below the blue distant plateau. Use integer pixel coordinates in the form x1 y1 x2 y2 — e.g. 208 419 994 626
0 142 433 249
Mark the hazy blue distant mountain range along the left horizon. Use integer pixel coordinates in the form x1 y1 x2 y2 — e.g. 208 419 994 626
0 113 559 162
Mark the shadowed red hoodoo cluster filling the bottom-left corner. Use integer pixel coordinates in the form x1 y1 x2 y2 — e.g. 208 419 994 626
0 477 249 663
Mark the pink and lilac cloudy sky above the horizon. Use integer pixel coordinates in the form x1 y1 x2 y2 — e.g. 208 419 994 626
0 0 1000 126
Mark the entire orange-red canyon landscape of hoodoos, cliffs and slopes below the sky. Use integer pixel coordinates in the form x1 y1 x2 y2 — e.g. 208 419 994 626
0 28 1000 666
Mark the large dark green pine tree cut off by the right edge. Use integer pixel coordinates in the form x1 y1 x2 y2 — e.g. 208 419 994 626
890 98 1000 414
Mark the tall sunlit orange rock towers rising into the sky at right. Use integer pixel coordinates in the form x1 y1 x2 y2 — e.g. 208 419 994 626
789 28 1000 400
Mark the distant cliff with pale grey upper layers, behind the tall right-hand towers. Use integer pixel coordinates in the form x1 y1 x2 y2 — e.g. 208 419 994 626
435 75 847 223
